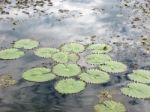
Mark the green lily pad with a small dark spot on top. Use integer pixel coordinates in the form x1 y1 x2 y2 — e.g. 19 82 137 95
87 44 112 54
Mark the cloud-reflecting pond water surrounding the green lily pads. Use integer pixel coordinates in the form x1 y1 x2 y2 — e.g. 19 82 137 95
0 0 150 112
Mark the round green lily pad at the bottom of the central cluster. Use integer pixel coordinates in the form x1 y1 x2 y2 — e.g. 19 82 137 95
55 79 86 94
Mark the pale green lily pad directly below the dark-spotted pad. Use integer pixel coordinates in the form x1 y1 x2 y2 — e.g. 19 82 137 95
86 54 111 64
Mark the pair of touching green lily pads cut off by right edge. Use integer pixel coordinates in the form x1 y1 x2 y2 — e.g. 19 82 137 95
121 69 150 98
